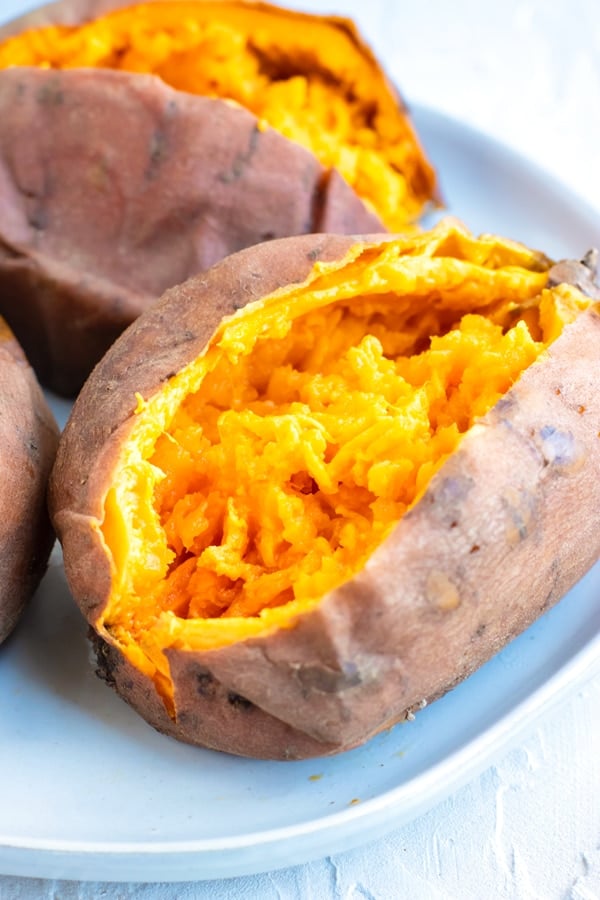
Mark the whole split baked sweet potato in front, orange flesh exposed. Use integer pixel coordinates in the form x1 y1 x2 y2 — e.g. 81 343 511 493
50 221 600 758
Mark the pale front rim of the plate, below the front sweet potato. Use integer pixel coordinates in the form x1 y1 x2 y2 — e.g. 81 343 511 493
0 632 600 884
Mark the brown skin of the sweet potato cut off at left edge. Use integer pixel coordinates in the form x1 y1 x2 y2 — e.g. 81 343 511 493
0 320 58 643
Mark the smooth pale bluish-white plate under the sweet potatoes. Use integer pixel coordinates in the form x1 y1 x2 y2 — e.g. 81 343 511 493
0 103 600 881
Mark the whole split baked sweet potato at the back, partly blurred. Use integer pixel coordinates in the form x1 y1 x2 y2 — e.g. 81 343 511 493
0 0 437 395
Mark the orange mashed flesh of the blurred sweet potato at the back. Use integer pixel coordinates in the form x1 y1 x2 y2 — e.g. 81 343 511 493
0 0 433 230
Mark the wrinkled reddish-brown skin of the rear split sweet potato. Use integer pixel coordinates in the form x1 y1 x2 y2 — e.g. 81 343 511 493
0 67 382 396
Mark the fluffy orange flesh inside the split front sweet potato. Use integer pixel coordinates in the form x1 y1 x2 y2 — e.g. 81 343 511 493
99 229 586 702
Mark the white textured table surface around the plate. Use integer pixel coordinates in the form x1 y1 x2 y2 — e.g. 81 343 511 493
0 0 600 900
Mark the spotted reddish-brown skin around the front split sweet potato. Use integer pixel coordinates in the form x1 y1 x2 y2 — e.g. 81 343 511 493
50 236 600 759
